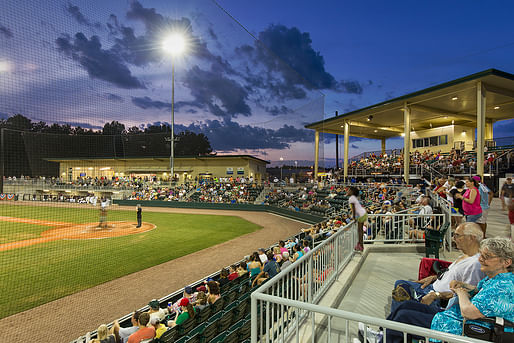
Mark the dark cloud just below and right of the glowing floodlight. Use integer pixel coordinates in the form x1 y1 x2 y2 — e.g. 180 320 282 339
183 66 251 117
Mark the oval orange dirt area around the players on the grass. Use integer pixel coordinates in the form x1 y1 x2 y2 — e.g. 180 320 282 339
41 222 155 239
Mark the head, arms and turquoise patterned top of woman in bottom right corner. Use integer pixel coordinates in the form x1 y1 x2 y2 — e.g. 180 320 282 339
431 238 514 335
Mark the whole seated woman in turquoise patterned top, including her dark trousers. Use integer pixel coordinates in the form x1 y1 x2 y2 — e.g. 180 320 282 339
359 237 514 343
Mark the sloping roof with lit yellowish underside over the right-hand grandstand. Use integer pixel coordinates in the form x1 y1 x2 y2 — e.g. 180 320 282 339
305 69 514 139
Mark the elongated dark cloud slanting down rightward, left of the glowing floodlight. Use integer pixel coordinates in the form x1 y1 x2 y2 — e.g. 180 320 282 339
55 32 146 89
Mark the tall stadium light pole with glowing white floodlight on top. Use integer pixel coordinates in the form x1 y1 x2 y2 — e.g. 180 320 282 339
162 33 186 188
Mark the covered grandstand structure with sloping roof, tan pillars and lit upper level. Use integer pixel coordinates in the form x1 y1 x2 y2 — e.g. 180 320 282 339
305 69 514 182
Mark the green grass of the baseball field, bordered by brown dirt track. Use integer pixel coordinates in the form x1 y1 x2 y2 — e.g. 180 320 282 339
0 205 260 318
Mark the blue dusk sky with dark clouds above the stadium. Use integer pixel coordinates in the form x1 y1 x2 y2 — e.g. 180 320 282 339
0 0 514 165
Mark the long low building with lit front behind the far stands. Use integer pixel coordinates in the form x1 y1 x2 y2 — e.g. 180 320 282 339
48 155 269 183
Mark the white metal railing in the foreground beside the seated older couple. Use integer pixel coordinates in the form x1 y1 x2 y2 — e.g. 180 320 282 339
251 218 484 343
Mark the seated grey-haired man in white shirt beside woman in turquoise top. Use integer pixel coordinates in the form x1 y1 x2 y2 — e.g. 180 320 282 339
391 223 484 312
